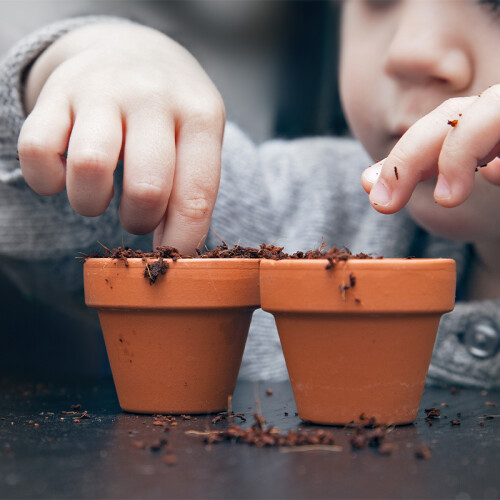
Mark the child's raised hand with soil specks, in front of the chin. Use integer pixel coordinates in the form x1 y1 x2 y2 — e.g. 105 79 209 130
362 85 500 214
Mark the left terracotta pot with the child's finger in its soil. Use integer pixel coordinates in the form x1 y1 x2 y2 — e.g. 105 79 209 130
84 258 260 414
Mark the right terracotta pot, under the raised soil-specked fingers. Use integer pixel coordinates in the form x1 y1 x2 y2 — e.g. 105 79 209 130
260 259 456 425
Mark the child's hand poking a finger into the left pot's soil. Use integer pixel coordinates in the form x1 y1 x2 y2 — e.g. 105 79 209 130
18 24 225 253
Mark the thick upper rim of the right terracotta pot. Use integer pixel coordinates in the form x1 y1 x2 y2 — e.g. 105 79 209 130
260 259 456 314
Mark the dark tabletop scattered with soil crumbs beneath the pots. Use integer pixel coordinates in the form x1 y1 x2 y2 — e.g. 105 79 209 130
0 379 500 499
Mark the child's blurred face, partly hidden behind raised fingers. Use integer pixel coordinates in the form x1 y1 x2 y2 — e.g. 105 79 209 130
340 0 500 239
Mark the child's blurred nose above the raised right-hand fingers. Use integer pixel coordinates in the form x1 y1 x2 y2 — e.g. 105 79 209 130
385 1 473 92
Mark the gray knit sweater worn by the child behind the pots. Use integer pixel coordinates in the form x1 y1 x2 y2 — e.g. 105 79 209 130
0 17 500 388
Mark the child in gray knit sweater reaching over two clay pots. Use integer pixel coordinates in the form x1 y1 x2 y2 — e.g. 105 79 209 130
0 0 500 387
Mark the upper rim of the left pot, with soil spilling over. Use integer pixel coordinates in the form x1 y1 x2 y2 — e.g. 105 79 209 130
83 258 260 310
